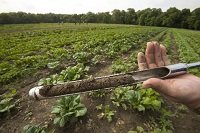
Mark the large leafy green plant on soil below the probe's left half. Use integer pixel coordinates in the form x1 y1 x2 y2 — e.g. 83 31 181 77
51 95 87 127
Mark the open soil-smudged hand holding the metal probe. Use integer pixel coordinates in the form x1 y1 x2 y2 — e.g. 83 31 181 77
138 42 200 109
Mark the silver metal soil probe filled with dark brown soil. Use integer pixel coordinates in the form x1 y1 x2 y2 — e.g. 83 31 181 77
29 62 200 100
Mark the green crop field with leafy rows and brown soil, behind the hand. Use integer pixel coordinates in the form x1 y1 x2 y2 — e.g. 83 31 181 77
0 23 200 133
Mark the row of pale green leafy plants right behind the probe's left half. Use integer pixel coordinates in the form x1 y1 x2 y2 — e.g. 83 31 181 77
38 64 89 85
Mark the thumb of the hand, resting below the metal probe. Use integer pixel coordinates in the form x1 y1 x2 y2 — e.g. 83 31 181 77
143 78 172 95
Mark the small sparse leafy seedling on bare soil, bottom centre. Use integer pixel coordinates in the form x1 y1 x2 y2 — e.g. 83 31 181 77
96 104 116 122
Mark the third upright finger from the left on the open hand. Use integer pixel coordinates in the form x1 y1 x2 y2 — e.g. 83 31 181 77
153 42 165 67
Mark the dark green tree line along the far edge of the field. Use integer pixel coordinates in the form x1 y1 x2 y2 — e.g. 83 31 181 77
0 7 200 30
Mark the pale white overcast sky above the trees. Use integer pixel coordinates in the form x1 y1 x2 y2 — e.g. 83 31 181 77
0 0 200 14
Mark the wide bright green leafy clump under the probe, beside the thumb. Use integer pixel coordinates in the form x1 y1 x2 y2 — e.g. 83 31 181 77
111 87 163 111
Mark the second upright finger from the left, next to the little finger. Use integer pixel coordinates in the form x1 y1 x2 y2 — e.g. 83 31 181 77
145 42 157 68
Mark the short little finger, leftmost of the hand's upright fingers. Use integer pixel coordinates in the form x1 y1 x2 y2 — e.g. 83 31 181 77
137 52 148 70
